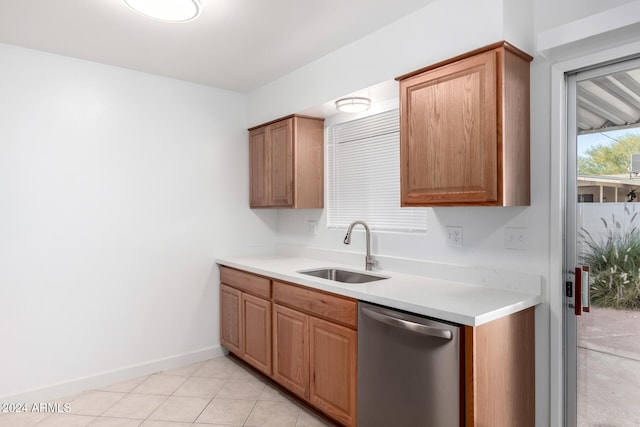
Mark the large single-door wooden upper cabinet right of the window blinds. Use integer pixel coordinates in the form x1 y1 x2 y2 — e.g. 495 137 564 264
397 42 533 206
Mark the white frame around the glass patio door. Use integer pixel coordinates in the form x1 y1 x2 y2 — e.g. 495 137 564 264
549 41 640 427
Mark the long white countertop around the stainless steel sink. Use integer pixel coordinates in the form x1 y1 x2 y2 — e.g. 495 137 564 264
216 255 542 326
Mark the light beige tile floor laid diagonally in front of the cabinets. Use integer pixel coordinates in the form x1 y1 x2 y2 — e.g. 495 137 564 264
0 357 332 427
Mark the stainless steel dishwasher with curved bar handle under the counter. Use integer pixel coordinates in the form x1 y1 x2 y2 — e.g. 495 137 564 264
358 302 464 427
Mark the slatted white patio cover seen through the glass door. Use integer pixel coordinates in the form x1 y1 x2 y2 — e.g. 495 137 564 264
577 68 640 134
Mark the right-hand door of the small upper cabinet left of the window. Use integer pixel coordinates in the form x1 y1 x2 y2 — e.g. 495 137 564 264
269 119 293 206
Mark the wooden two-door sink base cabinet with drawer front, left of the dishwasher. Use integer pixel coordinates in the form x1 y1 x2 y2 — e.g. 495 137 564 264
273 281 358 426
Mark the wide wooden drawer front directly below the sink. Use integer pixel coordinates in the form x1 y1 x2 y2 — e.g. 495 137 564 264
273 280 358 329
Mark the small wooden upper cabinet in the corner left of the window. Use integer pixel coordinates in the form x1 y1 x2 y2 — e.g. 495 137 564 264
249 115 324 208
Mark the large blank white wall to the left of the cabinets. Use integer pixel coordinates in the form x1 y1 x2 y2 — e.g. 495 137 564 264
0 44 276 402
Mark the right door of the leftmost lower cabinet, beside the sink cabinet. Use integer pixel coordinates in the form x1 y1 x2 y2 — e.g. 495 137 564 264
242 293 271 375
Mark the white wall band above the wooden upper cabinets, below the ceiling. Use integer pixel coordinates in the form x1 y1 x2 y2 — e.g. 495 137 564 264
248 0 504 125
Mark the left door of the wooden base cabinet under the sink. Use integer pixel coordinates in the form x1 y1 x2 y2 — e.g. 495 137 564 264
273 304 309 399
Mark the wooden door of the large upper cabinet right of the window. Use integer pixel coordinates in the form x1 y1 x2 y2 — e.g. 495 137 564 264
400 50 499 206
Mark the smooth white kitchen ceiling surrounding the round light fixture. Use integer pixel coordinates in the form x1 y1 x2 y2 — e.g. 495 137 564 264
0 0 433 93
